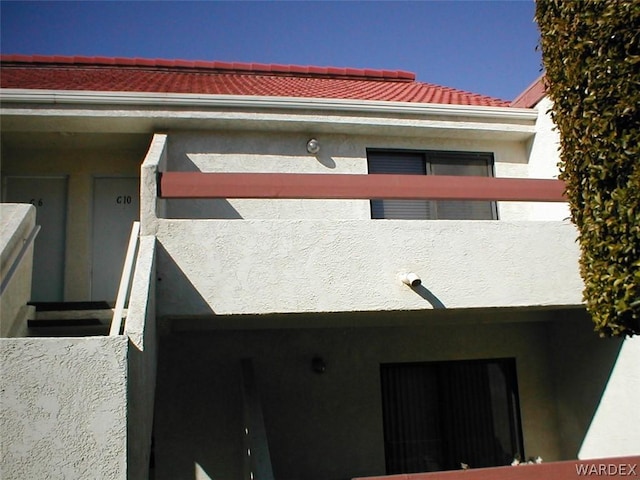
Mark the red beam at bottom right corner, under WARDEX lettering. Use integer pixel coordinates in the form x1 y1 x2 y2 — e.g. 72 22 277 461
353 456 640 480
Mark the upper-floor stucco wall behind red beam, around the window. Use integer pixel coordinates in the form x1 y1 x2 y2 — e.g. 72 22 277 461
161 130 567 221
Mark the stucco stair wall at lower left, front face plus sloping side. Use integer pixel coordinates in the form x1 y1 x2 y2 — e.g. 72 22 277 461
0 237 156 480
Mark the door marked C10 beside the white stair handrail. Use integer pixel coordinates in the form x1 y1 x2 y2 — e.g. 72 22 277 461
91 177 140 303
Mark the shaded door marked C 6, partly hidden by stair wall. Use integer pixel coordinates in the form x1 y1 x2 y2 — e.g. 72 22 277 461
5 176 67 302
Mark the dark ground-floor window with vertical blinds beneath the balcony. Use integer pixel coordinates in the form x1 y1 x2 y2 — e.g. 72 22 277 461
380 359 524 475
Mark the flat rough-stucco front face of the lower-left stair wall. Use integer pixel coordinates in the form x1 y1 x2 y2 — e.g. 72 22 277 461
0 336 128 480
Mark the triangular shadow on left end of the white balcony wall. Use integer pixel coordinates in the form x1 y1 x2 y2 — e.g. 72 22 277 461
156 241 216 318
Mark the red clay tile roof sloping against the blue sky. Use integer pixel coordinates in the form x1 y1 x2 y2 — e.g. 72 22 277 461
0 55 509 107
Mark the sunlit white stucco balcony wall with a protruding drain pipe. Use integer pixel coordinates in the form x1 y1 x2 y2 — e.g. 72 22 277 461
158 220 582 316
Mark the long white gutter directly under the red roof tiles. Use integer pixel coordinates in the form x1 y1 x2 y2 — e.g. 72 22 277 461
0 89 538 123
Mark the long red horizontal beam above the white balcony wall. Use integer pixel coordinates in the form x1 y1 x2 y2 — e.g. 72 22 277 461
160 172 566 202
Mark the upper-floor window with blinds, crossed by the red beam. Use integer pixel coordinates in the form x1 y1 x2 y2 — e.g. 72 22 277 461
367 150 497 220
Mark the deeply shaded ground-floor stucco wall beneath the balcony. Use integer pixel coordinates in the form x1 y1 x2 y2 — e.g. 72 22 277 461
156 309 600 480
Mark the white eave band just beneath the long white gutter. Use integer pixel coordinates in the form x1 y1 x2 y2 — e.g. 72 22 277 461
0 104 535 141
